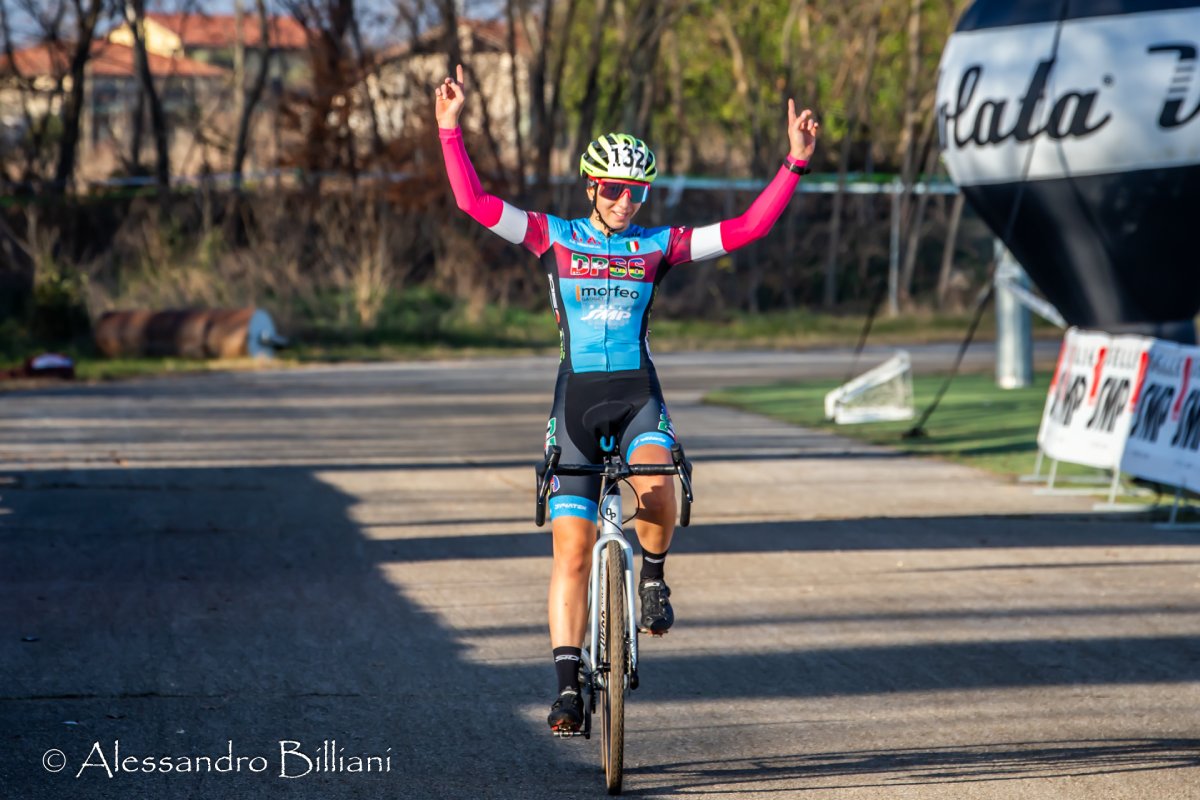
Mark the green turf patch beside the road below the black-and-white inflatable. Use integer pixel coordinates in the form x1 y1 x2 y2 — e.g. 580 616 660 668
706 374 1096 475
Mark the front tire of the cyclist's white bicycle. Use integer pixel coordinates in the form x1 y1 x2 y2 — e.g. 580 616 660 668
600 542 630 794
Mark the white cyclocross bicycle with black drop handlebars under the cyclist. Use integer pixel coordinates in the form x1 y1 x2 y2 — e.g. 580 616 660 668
535 444 692 794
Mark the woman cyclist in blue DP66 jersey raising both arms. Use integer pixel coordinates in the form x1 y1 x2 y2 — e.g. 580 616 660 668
436 65 820 732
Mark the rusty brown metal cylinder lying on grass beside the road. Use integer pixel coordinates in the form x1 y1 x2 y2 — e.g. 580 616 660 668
94 308 282 359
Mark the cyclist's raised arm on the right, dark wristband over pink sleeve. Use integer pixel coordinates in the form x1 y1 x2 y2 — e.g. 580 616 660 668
672 100 821 261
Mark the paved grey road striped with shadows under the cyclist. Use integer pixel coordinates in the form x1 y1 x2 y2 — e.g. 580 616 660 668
0 348 1200 800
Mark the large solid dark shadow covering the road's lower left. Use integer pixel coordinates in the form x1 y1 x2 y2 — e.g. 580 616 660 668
0 468 594 800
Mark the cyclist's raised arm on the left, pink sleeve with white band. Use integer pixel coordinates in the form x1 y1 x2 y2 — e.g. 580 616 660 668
434 64 546 254
